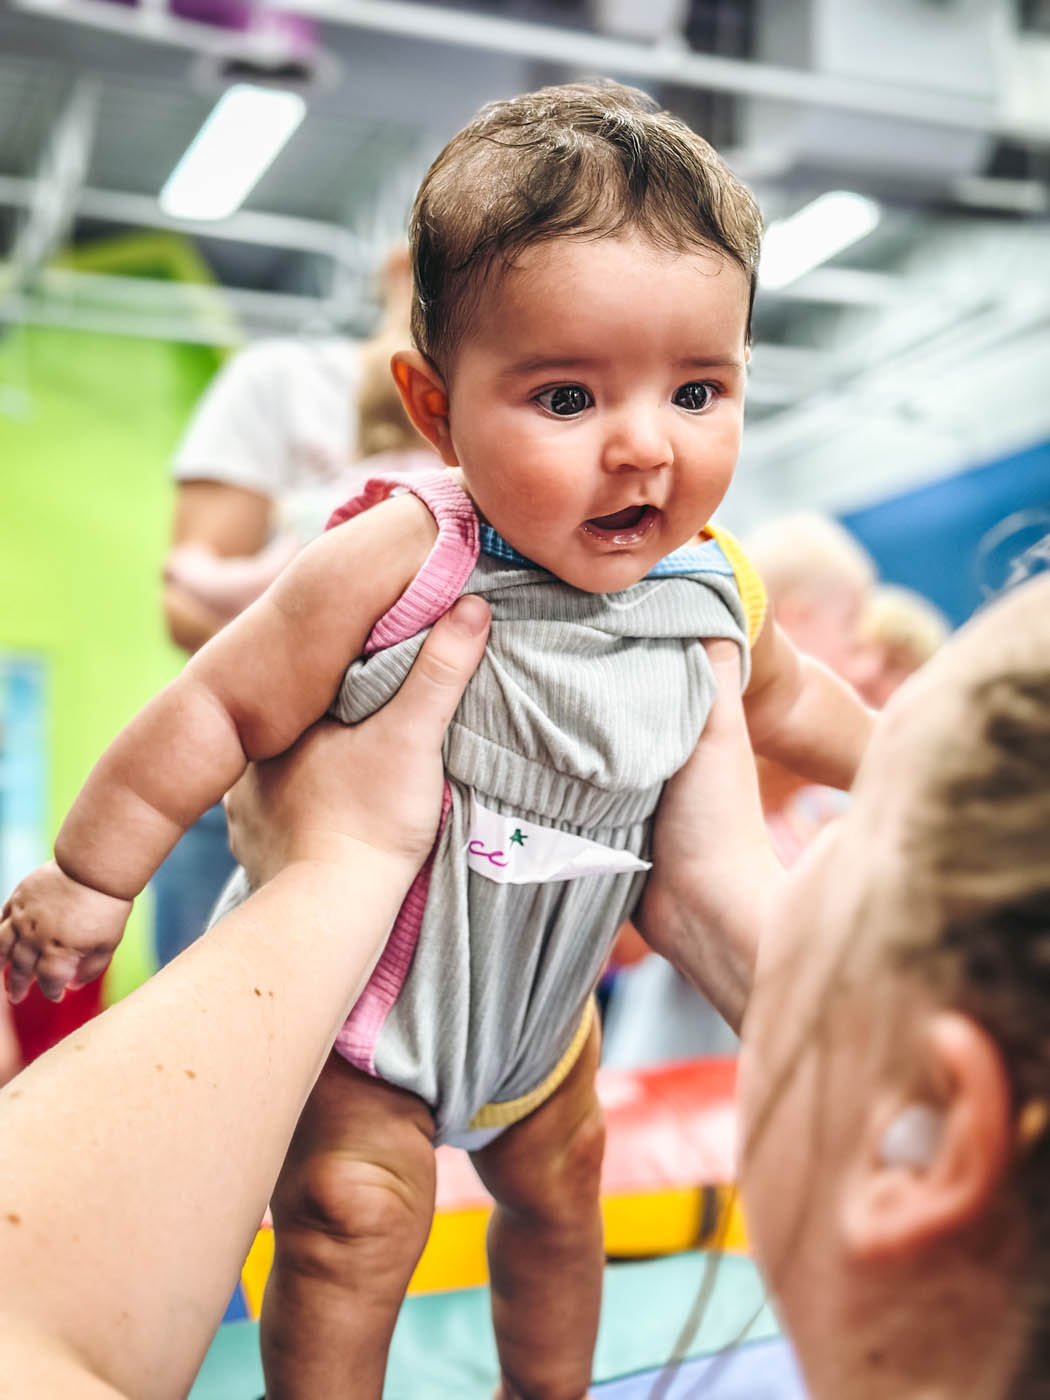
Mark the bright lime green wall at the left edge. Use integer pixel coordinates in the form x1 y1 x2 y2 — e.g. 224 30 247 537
0 328 217 1000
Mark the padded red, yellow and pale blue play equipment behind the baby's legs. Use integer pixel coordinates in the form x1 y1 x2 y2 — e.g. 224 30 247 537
190 1058 804 1400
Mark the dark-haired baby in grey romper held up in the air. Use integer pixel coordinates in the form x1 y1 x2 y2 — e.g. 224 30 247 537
0 84 869 1400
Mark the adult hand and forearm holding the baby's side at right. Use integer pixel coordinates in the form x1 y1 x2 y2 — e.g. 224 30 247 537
636 641 784 1030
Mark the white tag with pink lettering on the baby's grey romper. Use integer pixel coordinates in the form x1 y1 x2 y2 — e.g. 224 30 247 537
466 794 651 885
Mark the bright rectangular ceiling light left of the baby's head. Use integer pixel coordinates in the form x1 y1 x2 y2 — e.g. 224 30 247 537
160 83 307 218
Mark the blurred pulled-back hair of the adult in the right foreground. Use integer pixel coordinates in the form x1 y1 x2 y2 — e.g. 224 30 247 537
890 577 1050 1400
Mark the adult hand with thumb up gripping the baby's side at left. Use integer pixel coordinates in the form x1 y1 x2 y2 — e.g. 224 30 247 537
225 596 489 886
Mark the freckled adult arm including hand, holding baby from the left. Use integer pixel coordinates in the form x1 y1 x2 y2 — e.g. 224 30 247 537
0 599 487 1400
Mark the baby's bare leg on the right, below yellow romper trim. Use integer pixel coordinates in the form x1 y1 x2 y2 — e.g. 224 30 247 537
472 1022 605 1400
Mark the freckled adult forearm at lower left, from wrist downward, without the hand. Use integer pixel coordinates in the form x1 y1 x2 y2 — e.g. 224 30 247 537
0 846 412 1400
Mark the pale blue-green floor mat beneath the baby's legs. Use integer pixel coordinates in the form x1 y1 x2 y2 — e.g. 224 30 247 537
190 1253 804 1400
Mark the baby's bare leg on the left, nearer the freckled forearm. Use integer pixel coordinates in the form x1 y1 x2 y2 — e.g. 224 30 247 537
259 1053 434 1400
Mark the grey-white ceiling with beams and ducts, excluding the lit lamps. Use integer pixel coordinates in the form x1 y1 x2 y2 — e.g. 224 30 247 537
0 0 1050 524
